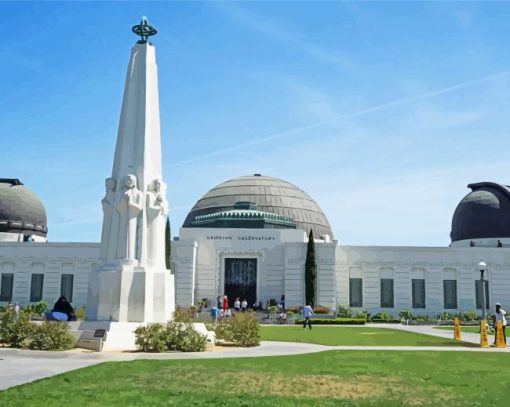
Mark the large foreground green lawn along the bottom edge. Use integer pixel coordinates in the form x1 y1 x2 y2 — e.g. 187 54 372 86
0 351 510 407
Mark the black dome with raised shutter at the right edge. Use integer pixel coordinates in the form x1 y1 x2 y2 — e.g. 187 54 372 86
450 182 510 242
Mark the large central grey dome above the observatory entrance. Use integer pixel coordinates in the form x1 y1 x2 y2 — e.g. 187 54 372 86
182 174 333 238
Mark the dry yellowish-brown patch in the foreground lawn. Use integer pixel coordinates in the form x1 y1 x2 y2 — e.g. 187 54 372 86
131 366 454 406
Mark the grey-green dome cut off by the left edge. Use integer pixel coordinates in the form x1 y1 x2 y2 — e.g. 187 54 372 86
0 178 48 237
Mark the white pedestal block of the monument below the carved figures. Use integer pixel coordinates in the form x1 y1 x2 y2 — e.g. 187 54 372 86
86 265 175 323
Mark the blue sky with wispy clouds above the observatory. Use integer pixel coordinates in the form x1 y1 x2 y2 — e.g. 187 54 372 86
0 1 510 246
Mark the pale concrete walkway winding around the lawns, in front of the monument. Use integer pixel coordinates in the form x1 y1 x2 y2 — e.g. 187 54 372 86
0 324 510 390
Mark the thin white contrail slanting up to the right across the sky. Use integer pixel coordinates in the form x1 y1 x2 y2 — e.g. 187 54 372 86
167 70 510 169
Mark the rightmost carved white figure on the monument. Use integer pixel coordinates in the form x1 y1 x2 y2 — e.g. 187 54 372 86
147 179 168 262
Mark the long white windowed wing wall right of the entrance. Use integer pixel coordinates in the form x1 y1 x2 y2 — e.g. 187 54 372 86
335 246 510 316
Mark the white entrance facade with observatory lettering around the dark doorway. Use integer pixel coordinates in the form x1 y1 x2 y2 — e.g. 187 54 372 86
172 228 306 306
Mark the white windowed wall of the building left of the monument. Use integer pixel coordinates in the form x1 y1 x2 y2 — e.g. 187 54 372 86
0 242 99 307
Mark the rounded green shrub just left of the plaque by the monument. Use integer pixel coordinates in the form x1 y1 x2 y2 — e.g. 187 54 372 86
28 321 75 350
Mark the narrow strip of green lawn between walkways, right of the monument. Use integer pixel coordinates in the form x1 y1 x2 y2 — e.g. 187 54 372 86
260 325 469 346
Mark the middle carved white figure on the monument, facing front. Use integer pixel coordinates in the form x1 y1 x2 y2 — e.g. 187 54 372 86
117 174 143 260
